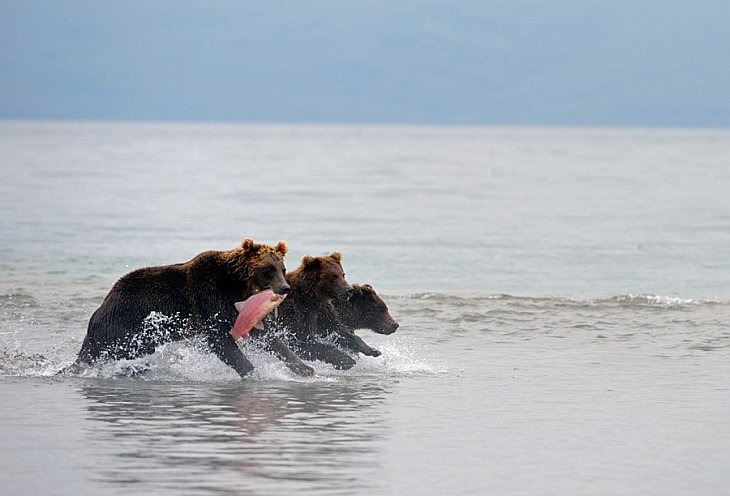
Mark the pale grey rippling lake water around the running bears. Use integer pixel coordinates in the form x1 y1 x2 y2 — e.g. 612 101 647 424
0 122 730 495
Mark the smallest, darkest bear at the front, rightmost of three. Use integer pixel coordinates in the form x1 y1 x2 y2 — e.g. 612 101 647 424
334 284 399 356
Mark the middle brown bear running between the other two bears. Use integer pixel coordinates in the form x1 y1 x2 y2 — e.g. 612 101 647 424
262 251 355 369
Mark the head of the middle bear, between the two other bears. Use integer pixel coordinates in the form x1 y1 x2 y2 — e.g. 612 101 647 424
296 251 352 301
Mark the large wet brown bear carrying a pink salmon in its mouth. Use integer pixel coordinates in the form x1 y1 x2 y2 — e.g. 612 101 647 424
67 238 290 377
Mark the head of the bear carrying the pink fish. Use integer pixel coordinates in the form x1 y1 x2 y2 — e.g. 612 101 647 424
236 238 291 294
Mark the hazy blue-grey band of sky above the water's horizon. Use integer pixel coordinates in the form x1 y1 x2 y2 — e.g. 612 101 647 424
0 0 730 128
